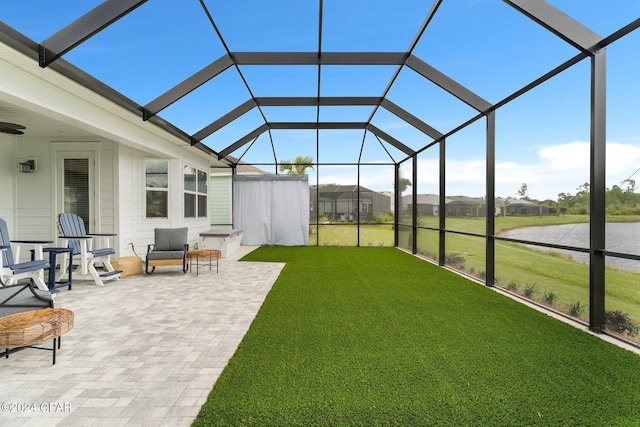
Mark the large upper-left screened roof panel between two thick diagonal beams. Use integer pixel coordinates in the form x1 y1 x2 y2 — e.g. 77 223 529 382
64 0 226 104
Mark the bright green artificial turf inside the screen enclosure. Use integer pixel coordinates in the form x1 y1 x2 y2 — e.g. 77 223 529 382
194 247 640 426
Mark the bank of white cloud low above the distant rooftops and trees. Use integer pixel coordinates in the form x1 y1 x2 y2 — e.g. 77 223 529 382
320 141 640 200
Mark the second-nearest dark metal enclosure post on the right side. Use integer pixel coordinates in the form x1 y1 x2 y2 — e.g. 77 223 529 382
485 111 496 286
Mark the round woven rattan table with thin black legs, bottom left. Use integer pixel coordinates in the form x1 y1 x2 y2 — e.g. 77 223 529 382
0 308 73 365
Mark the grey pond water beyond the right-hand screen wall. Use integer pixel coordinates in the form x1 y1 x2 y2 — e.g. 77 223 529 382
500 222 640 271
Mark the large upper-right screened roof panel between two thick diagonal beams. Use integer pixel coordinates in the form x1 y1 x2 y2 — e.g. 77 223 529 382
414 1 579 103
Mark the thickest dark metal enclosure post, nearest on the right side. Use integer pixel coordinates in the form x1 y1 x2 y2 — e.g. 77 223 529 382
589 49 607 332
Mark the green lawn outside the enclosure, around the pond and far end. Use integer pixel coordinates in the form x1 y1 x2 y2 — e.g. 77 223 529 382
312 215 640 332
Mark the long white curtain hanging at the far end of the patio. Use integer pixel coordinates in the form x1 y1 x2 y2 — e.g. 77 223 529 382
233 175 309 246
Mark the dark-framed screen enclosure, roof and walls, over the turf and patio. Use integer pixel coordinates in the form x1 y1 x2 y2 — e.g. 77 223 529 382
0 0 640 340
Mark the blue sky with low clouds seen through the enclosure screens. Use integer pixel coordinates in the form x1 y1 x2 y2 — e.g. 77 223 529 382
0 0 640 199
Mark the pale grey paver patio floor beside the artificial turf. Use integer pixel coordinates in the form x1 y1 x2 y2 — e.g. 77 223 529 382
0 247 284 427
